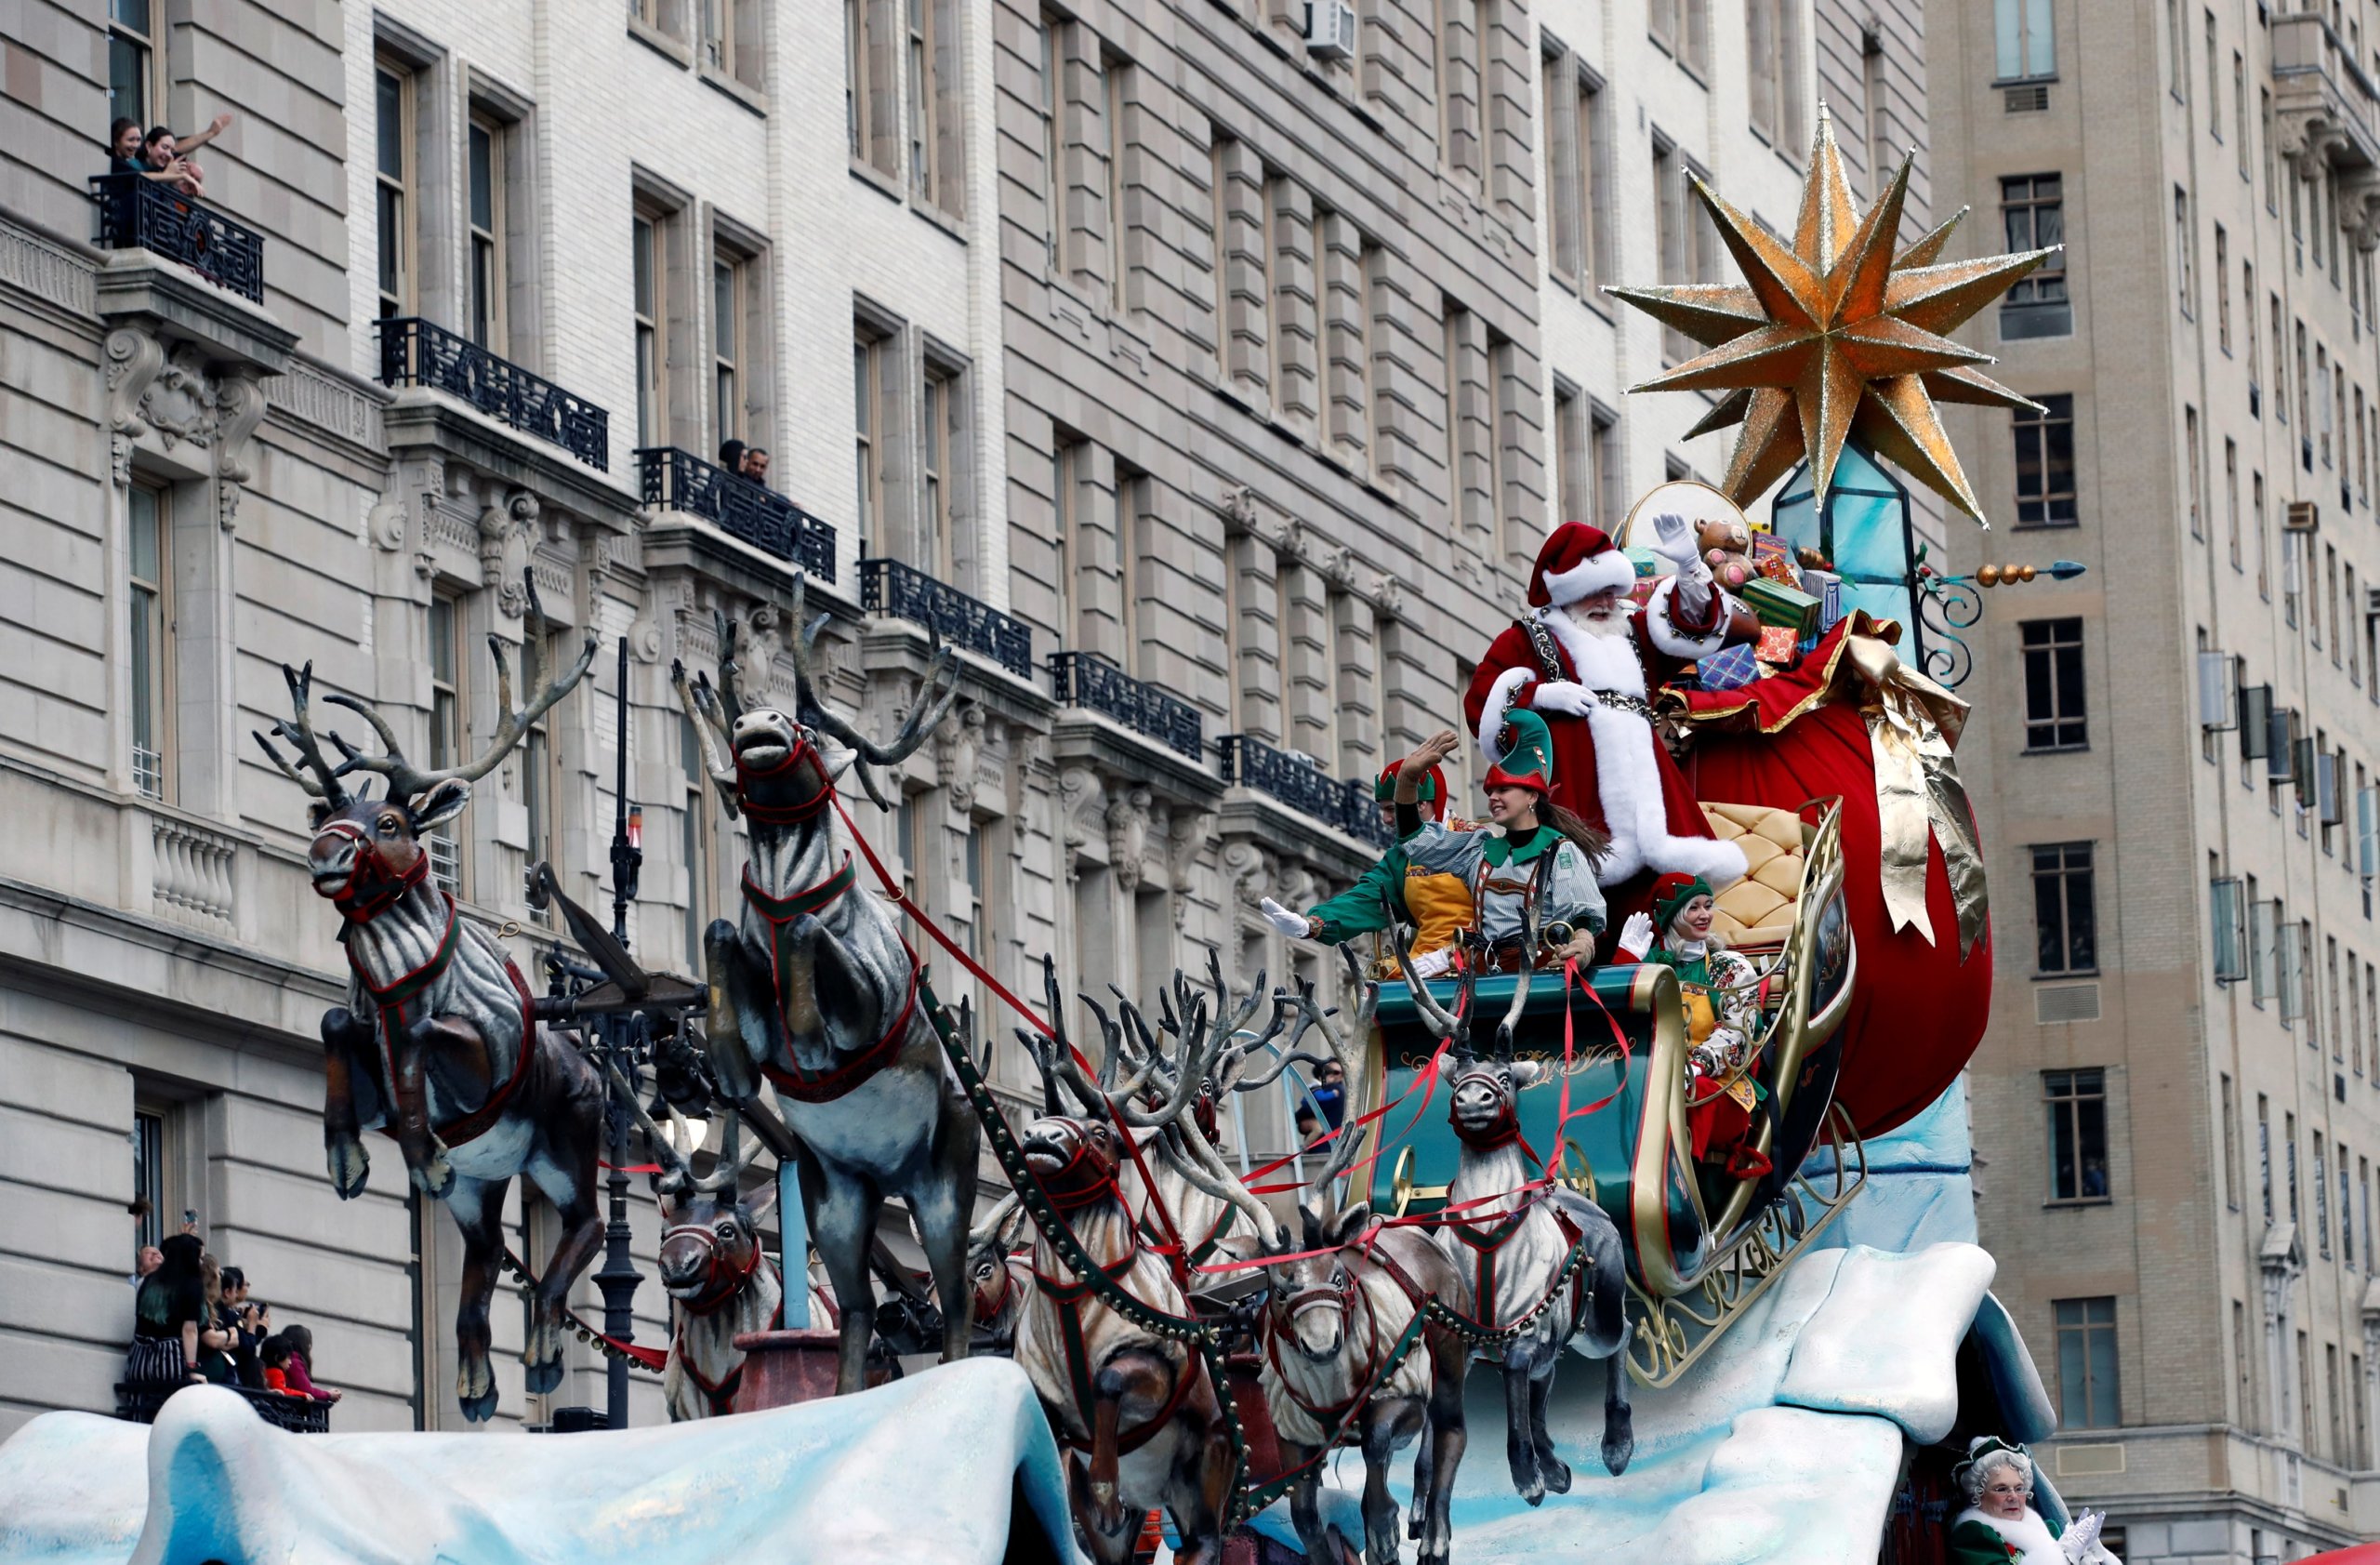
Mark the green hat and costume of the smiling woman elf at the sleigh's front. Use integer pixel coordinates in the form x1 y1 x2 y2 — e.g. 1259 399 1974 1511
1402 710 1604 964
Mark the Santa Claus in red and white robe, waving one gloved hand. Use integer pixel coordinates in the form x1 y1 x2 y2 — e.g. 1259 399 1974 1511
1463 522 1744 895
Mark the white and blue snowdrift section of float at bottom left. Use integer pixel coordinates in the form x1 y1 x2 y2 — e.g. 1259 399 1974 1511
0 1360 1074 1565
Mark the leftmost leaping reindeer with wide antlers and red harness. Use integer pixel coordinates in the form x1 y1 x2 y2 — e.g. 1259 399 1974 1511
257 586 602 1420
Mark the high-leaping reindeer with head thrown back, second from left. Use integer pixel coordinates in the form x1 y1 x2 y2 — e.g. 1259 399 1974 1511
671 574 981 1394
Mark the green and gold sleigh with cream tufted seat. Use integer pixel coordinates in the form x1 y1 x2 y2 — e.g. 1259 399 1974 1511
1364 801 1863 1386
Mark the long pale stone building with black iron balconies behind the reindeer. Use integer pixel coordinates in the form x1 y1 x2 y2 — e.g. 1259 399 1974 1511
0 0 1894 1432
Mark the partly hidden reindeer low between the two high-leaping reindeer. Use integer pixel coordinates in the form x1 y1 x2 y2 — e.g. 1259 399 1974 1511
614 1079 786 1425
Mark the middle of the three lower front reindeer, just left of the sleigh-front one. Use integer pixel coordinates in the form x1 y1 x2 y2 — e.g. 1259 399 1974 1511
1159 948 1471 1565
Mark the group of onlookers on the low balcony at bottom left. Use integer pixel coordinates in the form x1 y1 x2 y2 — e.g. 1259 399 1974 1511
124 1222 340 1403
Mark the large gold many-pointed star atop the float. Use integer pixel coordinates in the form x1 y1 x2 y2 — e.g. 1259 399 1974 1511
1604 102 2058 526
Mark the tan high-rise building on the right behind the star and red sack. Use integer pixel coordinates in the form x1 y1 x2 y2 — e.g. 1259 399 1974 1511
1928 0 2380 1560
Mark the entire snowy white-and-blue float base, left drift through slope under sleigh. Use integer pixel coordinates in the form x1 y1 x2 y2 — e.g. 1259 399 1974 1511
0 1089 2064 1565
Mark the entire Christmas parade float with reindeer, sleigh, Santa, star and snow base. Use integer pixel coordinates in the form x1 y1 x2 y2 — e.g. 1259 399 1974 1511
0 117 2107 1565
